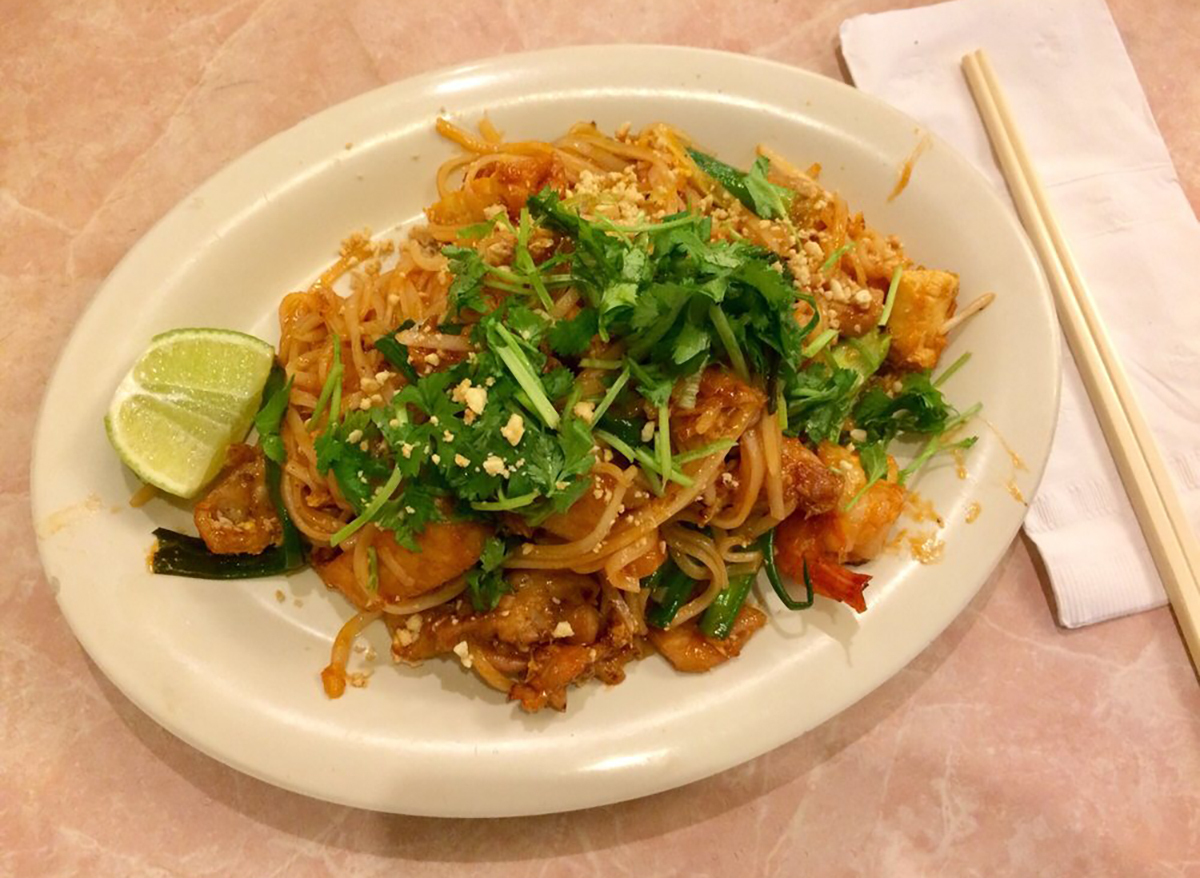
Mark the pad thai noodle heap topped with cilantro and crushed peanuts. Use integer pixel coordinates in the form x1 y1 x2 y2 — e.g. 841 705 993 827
155 119 977 711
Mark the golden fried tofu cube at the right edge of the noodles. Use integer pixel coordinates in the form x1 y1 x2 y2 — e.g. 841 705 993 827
888 269 959 369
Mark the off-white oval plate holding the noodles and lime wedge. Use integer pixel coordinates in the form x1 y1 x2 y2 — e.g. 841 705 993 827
32 47 1060 817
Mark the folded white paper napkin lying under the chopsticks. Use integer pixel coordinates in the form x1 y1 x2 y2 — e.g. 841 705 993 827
841 0 1200 627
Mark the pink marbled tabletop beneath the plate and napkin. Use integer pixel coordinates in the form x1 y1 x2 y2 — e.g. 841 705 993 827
0 0 1200 878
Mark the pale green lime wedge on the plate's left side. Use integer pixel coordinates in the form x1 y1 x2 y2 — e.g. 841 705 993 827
104 329 275 497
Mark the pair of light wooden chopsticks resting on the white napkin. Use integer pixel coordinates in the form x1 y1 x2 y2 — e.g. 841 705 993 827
962 50 1200 667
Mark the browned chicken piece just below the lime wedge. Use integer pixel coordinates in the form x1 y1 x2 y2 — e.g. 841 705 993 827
192 443 283 555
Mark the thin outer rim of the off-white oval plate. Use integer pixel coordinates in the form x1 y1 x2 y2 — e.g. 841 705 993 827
30 44 1063 816
